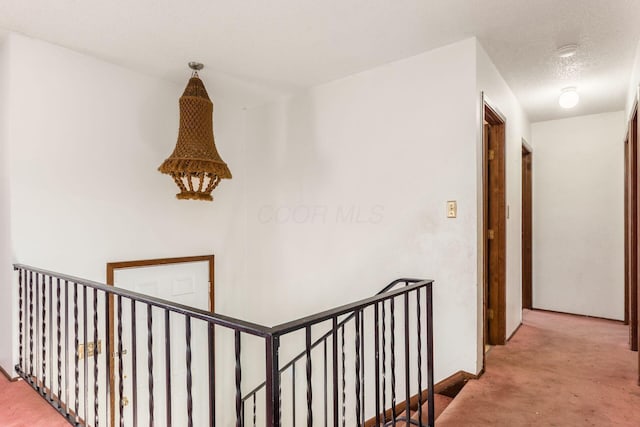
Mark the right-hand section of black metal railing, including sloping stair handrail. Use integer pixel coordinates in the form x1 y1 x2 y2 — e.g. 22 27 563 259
241 279 434 427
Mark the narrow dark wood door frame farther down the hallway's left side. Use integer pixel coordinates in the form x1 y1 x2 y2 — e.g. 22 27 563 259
522 139 533 309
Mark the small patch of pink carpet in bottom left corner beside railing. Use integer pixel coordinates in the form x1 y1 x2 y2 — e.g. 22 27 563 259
0 374 69 427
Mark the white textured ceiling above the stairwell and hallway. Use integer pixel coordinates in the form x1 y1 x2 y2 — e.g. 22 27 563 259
0 0 640 122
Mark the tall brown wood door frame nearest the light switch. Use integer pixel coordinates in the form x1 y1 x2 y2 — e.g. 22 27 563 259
482 94 507 352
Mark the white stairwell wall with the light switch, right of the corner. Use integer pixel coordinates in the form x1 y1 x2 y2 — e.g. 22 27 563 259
246 39 477 379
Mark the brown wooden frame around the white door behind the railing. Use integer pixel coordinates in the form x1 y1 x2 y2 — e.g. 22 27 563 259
106 255 215 427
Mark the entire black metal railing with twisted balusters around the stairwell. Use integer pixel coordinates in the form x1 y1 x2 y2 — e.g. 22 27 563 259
14 264 434 427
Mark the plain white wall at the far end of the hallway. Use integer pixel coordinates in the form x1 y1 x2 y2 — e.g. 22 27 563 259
532 111 626 320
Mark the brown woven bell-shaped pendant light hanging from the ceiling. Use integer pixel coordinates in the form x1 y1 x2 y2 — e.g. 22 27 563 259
158 62 231 201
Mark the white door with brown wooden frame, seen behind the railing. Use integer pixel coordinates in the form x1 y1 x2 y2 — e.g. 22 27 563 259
107 256 214 426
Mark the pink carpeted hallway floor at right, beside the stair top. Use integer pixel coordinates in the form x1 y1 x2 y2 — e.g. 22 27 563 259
436 311 640 427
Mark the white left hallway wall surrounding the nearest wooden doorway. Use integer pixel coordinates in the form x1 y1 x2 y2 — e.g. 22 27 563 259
476 43 531 351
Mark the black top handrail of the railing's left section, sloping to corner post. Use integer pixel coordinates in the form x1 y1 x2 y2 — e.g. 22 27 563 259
13 264 272 337
